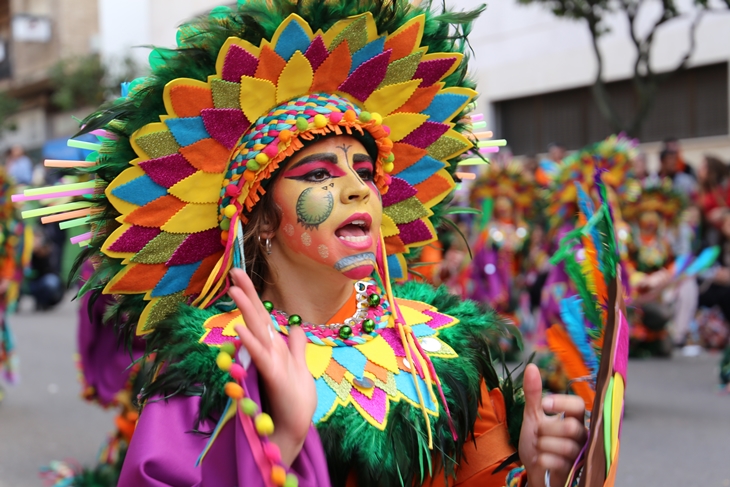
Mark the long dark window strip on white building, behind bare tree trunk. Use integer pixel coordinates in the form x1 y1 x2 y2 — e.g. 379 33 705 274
495 63 730 154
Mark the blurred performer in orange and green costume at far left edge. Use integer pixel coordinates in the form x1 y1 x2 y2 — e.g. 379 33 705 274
0 169 33 401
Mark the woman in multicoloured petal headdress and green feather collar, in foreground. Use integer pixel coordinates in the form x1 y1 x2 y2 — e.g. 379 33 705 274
31 1 596 486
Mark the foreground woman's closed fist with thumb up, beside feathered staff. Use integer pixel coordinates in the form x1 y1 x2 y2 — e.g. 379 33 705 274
519 364 587 487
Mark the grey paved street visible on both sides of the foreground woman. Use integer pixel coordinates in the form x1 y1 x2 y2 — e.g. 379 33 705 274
0 296 730 487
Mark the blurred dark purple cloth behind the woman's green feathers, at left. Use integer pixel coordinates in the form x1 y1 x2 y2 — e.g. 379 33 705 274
77 293 144 406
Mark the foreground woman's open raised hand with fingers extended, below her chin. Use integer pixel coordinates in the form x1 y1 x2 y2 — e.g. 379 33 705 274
228 269 317 466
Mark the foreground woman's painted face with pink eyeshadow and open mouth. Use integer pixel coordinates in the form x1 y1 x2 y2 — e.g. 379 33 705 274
272 135 383 279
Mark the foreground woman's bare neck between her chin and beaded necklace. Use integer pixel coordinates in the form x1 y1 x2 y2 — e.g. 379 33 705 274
261 264 353 323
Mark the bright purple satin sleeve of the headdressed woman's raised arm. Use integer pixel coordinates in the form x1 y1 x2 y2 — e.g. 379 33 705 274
118 365 330 487
